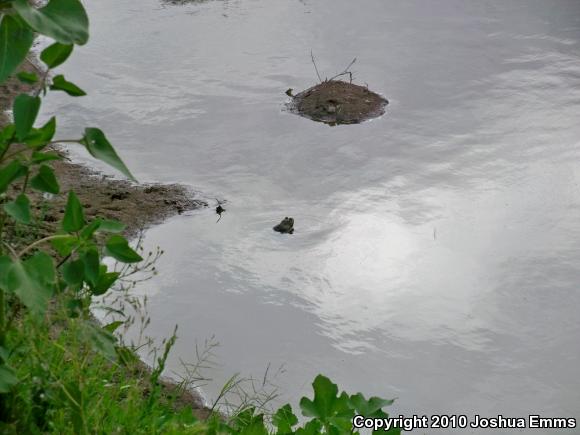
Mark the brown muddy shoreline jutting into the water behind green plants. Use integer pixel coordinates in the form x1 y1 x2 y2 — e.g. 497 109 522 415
0 60 210 418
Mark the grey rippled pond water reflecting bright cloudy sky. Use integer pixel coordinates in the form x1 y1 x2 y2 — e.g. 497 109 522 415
45 0 580 433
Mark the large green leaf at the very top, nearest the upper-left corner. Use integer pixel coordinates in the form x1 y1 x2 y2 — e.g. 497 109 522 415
13 0 89 45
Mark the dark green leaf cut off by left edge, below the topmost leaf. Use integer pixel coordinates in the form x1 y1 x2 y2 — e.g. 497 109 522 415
0 14 34 83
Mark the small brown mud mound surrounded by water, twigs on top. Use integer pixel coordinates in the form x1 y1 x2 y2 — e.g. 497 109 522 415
290 80 389 125
